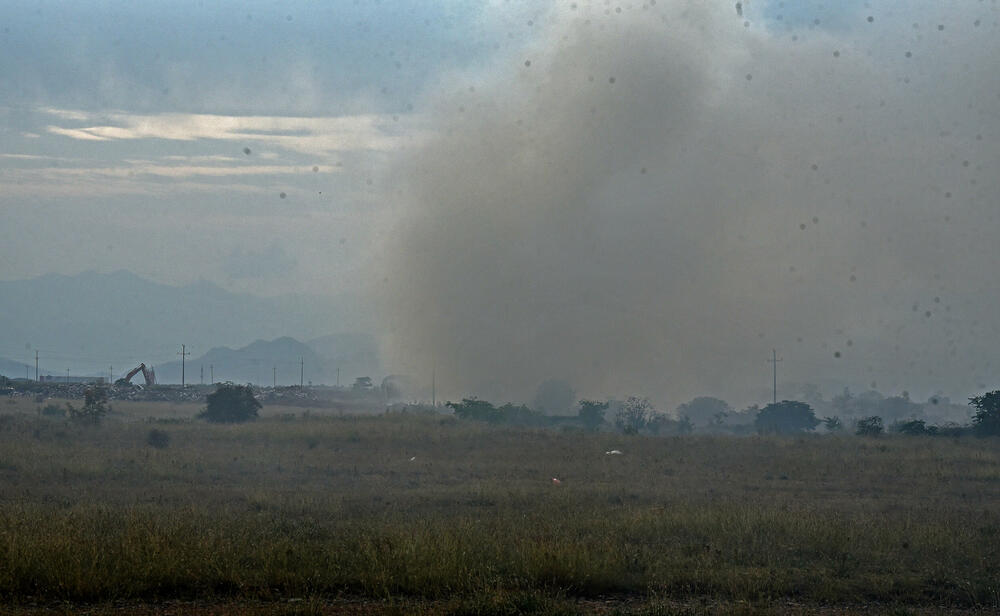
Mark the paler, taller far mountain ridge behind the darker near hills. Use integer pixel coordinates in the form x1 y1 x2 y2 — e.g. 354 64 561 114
0 270 370 382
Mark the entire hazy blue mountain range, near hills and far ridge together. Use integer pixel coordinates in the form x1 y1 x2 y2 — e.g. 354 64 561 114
0 270 378 384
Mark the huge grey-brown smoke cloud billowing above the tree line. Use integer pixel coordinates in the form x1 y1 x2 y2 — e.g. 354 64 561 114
371 0 1000 408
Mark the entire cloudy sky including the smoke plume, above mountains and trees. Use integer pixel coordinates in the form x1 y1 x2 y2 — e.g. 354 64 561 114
0 0 1000 408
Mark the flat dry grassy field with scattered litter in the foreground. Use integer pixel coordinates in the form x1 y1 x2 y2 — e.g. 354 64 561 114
0 401 1000 614
